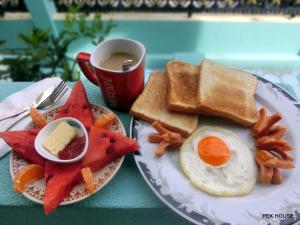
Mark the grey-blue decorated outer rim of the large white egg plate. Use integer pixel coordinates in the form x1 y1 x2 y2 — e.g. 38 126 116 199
129 74 300 225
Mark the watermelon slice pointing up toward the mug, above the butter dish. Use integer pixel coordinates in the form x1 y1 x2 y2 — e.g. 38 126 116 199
55 80 94 129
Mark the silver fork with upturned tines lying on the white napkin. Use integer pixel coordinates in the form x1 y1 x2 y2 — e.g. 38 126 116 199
0 81 68 131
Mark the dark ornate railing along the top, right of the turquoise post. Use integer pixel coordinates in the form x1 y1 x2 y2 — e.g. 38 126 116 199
55 0 300 16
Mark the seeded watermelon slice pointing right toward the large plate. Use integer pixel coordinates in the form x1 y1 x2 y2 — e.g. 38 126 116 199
82 127 139 171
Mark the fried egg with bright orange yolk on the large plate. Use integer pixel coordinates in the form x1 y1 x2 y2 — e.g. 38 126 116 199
180 126 257 196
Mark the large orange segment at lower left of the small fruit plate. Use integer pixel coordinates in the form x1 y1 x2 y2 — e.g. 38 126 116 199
13 164 45 192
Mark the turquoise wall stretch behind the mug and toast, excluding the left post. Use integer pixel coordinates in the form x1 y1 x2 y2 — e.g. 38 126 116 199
56 18 300 67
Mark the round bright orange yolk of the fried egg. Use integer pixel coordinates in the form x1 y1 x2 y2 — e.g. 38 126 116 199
198 136 230 166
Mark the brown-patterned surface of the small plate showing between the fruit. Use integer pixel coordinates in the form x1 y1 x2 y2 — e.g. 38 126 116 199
10 104 126 205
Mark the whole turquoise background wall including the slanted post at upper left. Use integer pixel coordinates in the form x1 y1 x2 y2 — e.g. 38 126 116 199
0 0 300 67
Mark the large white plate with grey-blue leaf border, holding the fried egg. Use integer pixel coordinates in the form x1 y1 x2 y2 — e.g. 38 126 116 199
130 77 300 225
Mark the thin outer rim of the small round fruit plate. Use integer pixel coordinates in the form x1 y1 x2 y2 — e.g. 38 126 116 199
9 103 126 205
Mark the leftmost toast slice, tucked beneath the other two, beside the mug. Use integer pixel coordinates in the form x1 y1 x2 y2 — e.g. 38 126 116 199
131 72 198 136
